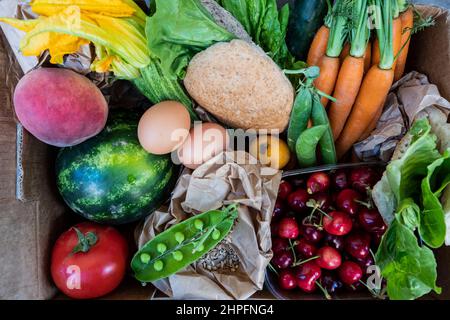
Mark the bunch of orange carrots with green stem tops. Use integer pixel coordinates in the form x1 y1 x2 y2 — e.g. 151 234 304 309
307 0 420 158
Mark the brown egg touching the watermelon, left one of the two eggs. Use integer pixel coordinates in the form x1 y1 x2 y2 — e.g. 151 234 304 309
138 101 191 154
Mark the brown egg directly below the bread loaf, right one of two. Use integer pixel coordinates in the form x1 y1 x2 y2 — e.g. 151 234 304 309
178 122 230 169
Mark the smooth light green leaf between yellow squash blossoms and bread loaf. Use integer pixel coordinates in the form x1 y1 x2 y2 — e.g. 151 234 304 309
146 0 236 79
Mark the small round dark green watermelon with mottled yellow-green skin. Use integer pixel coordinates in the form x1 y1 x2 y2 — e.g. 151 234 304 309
56 112 176 224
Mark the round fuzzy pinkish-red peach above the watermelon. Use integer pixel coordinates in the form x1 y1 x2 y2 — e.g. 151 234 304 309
14 68 108 147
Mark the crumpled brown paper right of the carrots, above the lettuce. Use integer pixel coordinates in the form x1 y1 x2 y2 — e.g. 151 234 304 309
354 71 450 162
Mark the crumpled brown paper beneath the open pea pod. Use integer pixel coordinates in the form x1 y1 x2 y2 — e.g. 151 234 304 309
136 152 281 299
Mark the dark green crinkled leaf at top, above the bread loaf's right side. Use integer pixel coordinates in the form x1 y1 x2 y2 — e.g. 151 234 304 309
218 0 293 68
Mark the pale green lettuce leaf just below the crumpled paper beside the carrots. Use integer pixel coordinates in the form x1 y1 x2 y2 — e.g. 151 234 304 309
386 119 441 203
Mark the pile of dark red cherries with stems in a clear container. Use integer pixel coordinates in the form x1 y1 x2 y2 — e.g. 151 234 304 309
270 167 387 298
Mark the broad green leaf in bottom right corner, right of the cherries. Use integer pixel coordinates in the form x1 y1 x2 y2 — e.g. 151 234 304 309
375 215 441 300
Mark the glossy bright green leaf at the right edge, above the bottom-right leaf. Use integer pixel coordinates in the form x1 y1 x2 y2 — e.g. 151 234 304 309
419 151 450 248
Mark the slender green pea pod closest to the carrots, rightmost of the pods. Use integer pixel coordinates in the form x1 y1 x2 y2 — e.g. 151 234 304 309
311 93 337 164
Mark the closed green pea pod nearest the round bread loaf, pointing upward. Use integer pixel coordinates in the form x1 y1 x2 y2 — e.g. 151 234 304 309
287 87 312 152
